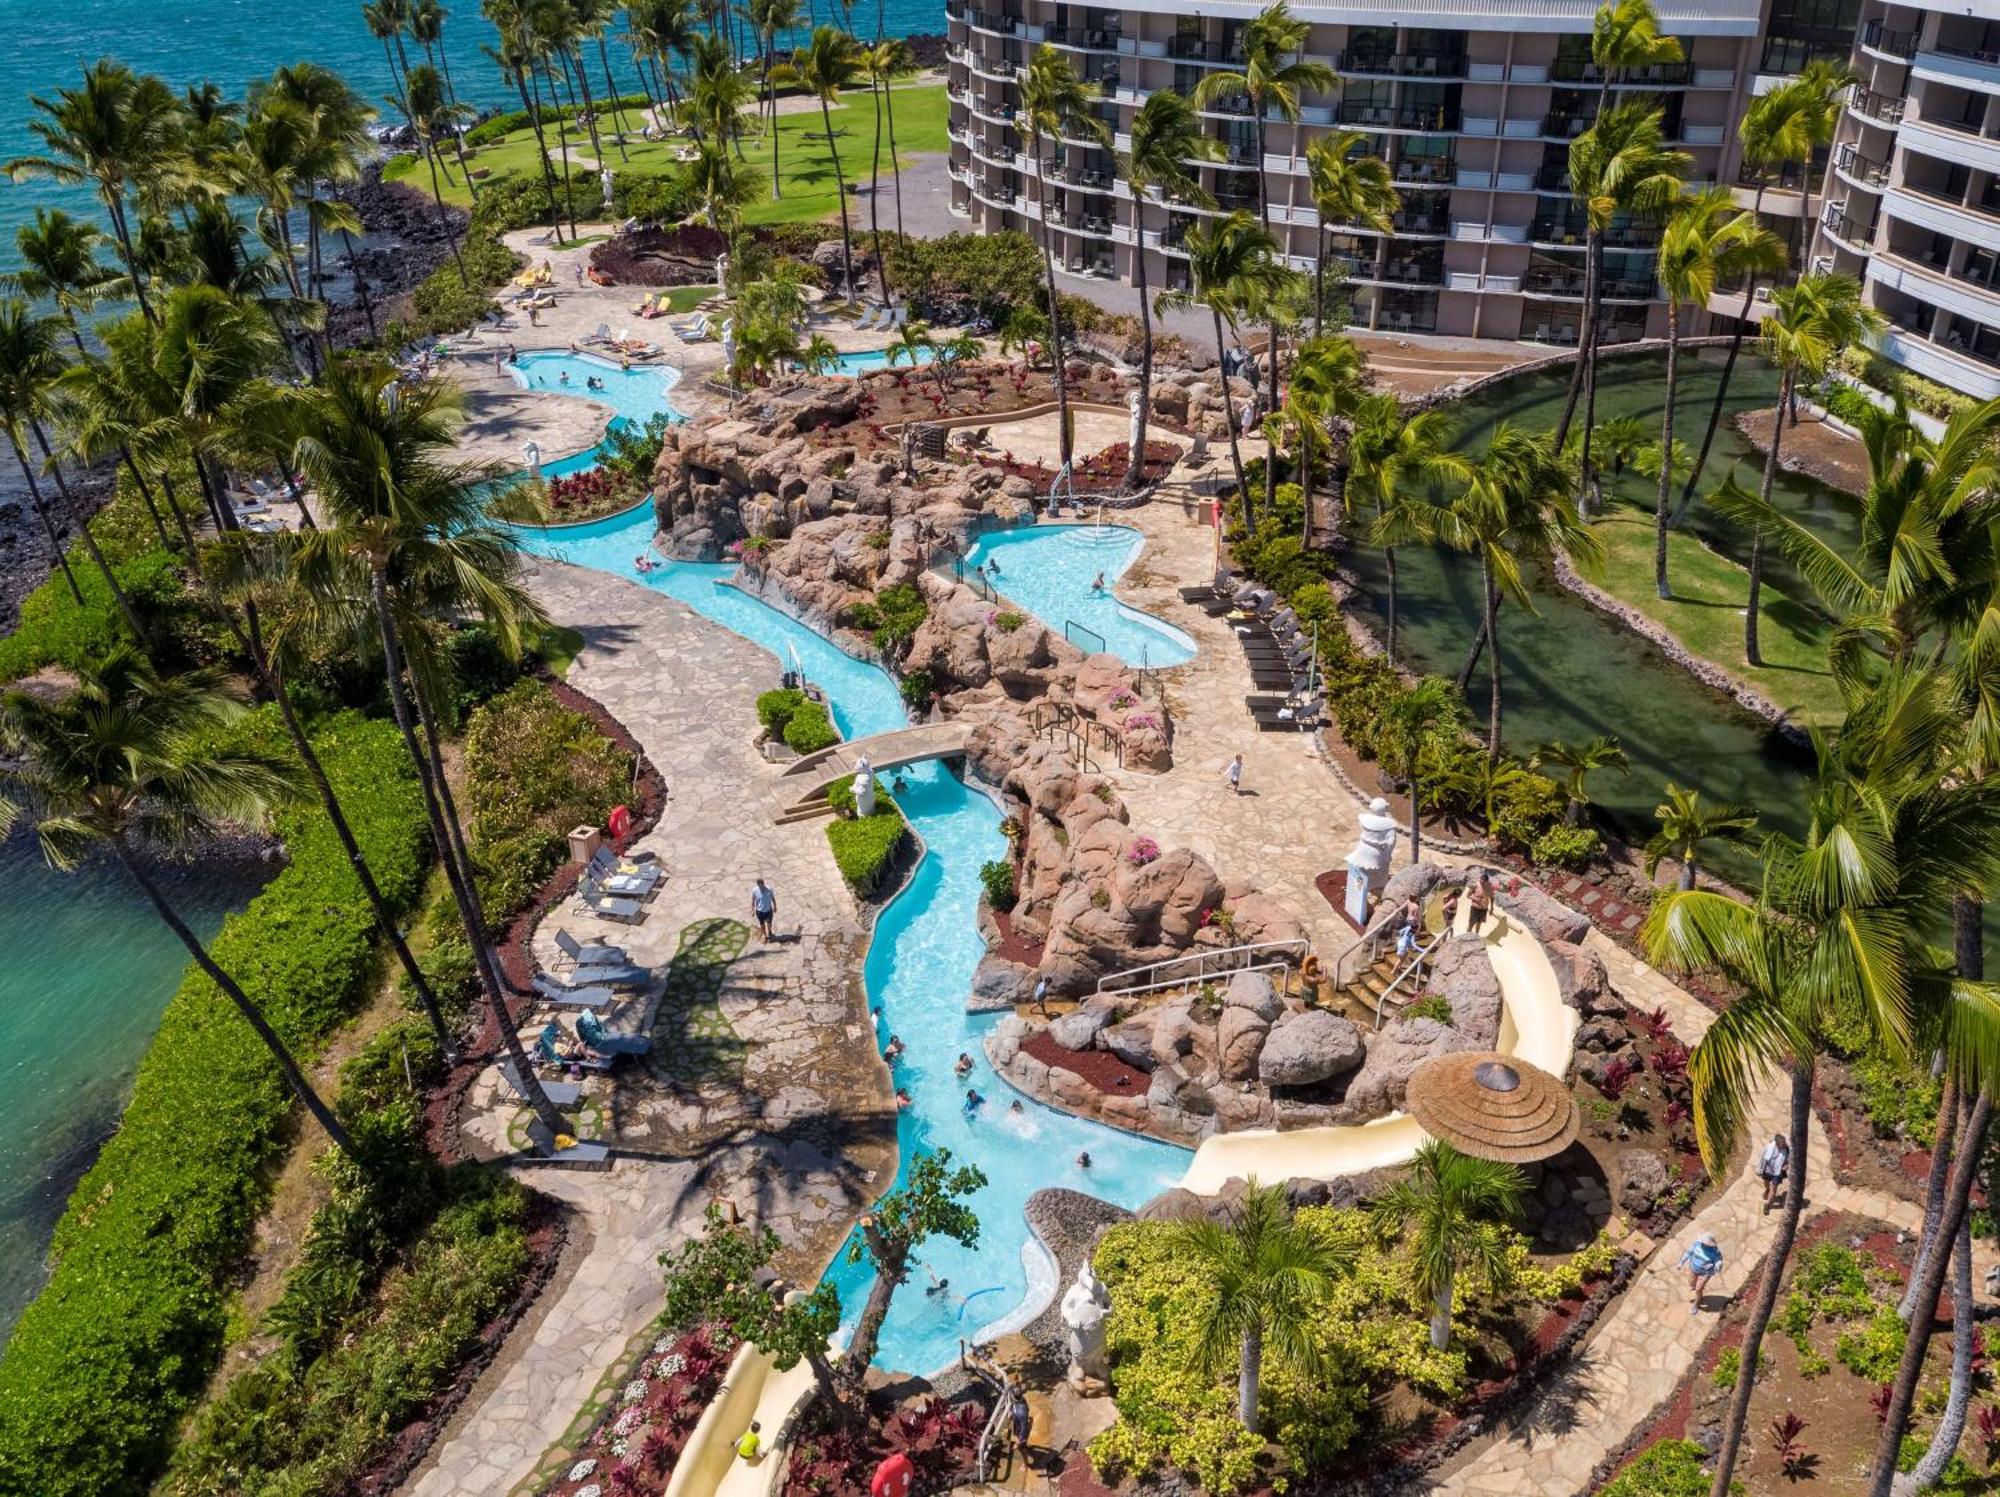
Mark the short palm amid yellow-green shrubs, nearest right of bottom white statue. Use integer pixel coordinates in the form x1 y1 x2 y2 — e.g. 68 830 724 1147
1174 1181 1354 1435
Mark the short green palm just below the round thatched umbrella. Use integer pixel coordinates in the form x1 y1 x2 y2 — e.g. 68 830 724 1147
1368 1139 1528 1351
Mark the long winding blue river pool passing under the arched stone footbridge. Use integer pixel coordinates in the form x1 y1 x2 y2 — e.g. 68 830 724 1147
524 506 1188 1373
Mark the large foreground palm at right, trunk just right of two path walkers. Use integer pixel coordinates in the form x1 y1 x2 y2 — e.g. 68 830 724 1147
1642 670 2000 1497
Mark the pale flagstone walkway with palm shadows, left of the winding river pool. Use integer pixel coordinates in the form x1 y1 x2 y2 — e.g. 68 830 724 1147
402 560 896 1497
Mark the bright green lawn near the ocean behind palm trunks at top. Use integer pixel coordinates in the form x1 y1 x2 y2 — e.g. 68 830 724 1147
398 84 950 228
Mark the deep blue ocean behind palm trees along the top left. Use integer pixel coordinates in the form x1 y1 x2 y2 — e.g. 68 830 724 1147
0 0 944 266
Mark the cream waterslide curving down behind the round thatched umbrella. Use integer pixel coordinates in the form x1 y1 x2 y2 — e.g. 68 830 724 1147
1180 899 1578 1195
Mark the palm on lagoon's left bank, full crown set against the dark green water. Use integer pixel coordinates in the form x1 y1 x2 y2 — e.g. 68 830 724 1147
1436 422 1602 761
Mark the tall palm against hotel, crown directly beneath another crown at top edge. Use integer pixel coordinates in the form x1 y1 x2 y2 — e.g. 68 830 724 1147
1556 101 1694 474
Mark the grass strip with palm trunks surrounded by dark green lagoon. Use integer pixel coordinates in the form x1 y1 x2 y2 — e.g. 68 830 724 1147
1592 500 1842 722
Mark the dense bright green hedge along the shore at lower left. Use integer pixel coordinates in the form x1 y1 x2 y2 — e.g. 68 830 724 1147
0 708 426 1497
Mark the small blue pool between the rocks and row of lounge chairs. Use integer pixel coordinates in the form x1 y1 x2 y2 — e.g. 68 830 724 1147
966 524 1196 666
